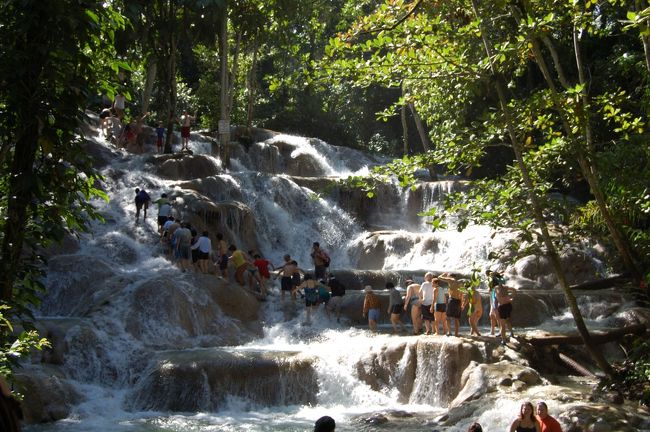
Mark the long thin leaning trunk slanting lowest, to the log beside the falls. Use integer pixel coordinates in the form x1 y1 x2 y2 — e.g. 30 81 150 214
472 0 613 376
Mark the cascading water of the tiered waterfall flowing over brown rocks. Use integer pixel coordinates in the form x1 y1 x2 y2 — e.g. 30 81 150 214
17 126 640 432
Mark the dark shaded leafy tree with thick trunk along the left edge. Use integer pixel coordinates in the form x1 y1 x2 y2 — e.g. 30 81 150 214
0 0 119 302
